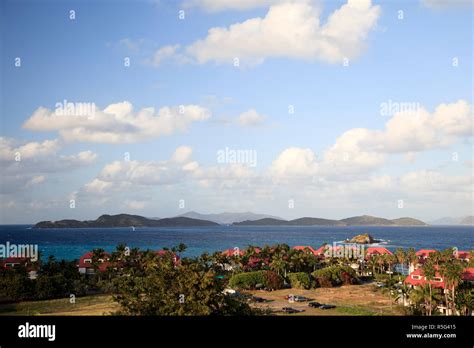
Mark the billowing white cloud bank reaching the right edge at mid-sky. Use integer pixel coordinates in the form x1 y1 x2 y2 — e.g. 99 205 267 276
322 100 474 175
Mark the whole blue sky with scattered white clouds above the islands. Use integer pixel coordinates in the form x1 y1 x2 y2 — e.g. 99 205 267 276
0 0 474 224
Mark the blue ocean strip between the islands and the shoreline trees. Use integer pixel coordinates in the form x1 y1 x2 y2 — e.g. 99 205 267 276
0 225 474 260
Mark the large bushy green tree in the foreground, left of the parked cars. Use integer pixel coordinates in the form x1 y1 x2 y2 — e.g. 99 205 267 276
114 247 255 315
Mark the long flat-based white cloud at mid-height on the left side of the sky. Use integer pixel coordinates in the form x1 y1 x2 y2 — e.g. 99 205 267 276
23 101 211 143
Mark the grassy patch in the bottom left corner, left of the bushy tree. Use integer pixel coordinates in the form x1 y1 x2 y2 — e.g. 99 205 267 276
0 295 119 315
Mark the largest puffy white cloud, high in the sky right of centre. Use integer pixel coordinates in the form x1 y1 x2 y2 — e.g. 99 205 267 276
158 0 380 65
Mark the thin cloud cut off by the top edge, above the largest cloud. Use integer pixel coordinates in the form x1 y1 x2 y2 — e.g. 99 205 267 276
183 0 282 12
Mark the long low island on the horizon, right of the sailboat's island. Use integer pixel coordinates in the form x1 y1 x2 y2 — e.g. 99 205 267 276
234 215 427 226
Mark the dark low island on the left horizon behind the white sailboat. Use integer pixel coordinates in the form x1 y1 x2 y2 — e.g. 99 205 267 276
33 214 219 228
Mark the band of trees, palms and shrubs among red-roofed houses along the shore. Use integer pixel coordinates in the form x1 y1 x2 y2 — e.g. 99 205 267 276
0 244 474 315
